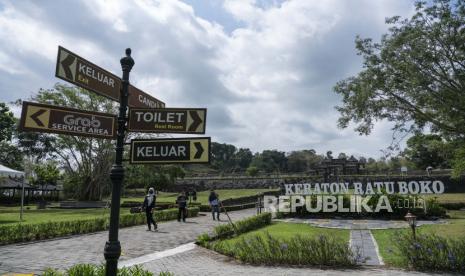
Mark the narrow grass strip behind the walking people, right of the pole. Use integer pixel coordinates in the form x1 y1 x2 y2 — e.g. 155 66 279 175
121 189 276 204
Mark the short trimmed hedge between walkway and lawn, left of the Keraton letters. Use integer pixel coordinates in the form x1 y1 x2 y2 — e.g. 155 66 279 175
214 213 271 238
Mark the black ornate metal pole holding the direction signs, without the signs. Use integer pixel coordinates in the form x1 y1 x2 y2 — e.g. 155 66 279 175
103 48 134 276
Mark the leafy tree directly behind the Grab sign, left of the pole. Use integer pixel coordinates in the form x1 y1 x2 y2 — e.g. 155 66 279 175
26 84 117 200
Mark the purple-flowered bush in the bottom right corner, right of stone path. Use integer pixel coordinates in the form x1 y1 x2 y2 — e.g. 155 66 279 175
395 231 465 272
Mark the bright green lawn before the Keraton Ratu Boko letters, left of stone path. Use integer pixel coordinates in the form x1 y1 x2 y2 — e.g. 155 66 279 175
221 222 350 244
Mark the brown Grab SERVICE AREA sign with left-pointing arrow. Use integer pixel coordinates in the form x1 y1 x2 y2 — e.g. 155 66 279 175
19 102 117 139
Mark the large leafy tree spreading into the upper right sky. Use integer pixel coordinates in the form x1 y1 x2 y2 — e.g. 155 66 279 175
334 0 465 175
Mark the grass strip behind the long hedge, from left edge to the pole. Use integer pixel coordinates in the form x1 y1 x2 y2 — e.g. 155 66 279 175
0 205 129 226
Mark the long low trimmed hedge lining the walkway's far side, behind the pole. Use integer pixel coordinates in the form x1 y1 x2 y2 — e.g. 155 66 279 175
0 208 199 245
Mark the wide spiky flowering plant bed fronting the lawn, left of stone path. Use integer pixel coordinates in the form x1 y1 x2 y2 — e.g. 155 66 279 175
212 232 360 267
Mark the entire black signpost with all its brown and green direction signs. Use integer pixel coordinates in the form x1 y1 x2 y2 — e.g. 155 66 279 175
20 46 211 276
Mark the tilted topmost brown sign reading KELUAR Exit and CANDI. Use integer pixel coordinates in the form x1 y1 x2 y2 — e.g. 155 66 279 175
55 46 165 108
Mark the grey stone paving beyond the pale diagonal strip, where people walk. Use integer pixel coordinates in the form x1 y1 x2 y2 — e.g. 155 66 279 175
0 209 255 275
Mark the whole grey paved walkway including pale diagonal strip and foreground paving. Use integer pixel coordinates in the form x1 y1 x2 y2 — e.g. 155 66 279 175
0 209 450 276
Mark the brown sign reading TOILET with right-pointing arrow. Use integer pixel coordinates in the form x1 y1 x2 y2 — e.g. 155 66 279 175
128 108 207 134
